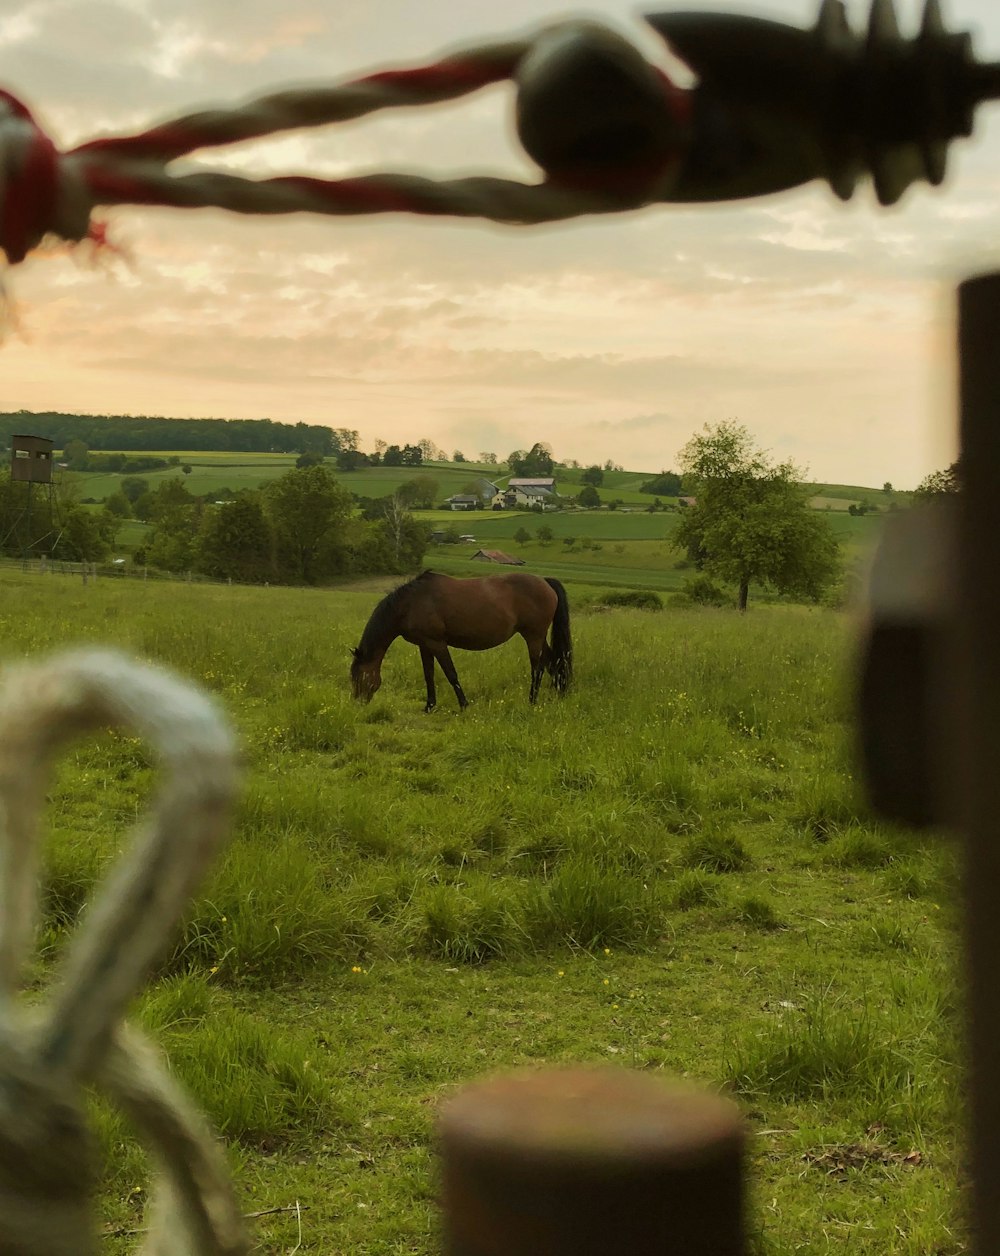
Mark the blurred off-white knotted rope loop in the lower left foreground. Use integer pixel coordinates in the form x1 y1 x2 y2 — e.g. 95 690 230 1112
0 651 249 1256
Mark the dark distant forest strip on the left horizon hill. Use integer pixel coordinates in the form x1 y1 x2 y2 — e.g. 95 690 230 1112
0 409 358 455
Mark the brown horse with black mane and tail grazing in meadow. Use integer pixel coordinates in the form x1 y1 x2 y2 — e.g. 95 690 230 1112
351 571 573 711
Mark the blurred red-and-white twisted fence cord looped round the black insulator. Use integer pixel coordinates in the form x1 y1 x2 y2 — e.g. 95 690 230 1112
0 22 691 263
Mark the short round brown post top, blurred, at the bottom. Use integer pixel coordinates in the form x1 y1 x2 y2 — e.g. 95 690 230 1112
440 1069 746 1256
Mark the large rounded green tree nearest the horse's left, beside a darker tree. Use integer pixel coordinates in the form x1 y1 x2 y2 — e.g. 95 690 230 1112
264 466 353 584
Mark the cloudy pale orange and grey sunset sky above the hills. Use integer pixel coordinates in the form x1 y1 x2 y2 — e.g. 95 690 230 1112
0 0 1000 487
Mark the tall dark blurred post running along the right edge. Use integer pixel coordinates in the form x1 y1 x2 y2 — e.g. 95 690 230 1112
954 273 1000 1256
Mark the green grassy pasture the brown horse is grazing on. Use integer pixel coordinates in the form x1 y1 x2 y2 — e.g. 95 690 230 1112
0 570 966 1256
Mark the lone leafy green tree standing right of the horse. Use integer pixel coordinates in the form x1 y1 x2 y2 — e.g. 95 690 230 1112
673 421 840 610
